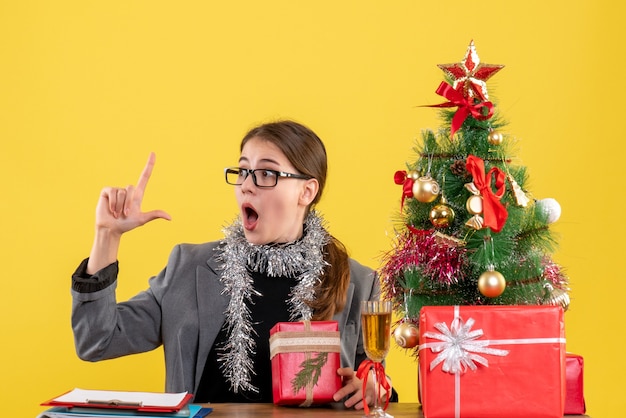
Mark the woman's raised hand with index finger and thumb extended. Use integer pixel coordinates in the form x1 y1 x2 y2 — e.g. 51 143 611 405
87 153 172 274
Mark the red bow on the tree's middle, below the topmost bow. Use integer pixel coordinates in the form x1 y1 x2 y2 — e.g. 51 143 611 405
465 155 509 232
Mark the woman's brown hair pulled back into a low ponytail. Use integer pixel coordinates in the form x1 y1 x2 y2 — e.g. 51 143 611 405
240 120 350 320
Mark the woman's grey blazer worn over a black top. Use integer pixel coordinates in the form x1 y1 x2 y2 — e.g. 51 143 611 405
72 242 380 393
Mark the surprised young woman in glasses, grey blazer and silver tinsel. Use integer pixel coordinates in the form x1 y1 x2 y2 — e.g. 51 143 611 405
72 121 388 409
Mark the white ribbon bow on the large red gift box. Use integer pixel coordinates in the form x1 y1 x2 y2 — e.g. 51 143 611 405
420 316 509 374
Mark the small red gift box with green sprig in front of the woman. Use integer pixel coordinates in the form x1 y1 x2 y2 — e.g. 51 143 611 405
270 321 341 406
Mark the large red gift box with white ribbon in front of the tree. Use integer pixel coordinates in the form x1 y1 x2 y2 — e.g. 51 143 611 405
418 306 565 418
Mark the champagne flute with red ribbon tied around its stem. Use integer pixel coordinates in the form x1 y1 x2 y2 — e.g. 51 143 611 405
361 300 393 418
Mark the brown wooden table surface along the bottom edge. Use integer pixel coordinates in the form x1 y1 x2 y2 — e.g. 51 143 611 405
197 403 586 418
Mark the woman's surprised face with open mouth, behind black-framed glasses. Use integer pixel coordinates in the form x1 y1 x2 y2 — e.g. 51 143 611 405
235 137 318 244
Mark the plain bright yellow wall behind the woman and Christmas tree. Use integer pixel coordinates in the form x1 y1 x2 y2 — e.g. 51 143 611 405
0 0 626 418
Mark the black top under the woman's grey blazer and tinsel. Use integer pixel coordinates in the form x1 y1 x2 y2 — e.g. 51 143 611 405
194 272 297 403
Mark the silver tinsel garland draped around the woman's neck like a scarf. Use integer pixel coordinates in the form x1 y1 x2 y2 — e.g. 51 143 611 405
218 211 330 393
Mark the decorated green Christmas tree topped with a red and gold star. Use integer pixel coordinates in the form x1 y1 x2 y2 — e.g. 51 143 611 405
379 41 569 348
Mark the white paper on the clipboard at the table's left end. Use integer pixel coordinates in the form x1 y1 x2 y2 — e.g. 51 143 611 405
53 388 187 407
